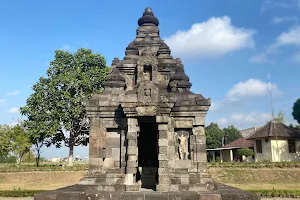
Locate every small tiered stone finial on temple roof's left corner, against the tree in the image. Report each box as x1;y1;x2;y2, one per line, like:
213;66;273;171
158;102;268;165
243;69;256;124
103;66;126;89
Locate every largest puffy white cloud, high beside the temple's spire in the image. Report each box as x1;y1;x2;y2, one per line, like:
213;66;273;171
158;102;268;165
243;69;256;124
165;16;255;57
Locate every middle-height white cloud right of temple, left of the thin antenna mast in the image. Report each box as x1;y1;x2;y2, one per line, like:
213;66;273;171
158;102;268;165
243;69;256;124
226;79;278;101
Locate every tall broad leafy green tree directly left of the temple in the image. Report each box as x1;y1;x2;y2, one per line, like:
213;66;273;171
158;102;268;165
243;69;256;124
21;49;109;166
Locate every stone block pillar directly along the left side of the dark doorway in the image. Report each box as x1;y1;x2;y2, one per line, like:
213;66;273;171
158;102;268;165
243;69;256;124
124;118;140;191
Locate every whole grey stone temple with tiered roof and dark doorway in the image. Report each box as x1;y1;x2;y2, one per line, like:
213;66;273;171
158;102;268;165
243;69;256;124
35;8;259;200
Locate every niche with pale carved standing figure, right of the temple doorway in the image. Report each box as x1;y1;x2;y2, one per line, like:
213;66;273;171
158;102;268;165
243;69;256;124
174;128;193;160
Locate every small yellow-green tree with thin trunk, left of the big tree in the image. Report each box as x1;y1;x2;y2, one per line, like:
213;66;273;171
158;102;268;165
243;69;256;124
10;124;32;166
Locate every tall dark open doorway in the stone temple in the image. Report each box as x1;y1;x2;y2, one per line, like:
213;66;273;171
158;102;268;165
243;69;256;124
137;117;158;190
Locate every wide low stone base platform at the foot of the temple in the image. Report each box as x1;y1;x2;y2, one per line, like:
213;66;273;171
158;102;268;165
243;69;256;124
34;184;260;200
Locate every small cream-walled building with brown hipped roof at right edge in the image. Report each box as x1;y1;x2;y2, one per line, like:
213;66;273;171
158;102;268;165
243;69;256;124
247;121;300;162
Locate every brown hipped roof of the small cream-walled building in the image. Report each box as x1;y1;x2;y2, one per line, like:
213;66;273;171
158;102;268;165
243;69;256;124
247;121;300;140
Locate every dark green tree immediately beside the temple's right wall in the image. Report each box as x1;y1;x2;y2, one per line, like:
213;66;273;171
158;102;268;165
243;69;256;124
205;123;224;149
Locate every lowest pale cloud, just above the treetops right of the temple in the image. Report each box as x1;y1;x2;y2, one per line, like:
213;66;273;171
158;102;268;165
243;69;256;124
217;112;272;127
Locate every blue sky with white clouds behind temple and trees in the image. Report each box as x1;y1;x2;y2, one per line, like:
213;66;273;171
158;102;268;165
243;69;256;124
0;0;300;157
